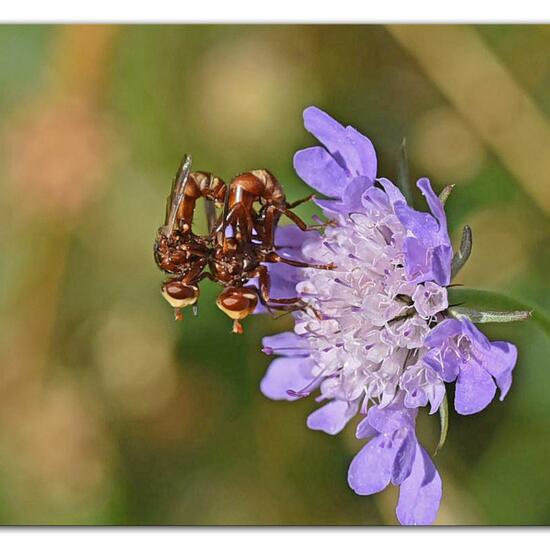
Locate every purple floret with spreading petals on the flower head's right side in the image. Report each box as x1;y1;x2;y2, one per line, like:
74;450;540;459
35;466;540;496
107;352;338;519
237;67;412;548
424;318;517;414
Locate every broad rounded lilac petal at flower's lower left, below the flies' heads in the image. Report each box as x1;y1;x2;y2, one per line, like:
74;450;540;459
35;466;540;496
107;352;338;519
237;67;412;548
260;357;314;401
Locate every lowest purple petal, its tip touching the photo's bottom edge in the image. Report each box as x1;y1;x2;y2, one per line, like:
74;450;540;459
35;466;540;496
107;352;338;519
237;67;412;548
396;443;441;525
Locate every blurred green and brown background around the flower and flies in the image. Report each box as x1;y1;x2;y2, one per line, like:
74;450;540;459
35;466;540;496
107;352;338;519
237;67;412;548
0;25;550;525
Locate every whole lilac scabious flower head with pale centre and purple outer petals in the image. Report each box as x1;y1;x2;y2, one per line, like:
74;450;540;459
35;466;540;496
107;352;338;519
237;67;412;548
261;107;517;524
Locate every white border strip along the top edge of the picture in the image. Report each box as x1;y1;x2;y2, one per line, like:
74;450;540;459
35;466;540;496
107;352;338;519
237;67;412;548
0;0;550;23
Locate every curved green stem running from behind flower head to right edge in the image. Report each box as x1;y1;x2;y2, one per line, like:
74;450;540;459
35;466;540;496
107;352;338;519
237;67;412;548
448;287;550;336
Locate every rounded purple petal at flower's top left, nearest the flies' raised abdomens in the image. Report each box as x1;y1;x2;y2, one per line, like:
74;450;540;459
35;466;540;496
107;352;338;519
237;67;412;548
294;147;349;198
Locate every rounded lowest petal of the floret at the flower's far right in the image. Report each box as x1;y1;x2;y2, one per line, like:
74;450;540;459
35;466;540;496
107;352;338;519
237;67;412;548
455;360;496;414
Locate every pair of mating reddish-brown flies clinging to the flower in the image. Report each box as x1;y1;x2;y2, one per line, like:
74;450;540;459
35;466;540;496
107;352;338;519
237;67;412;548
154;155;334;333
